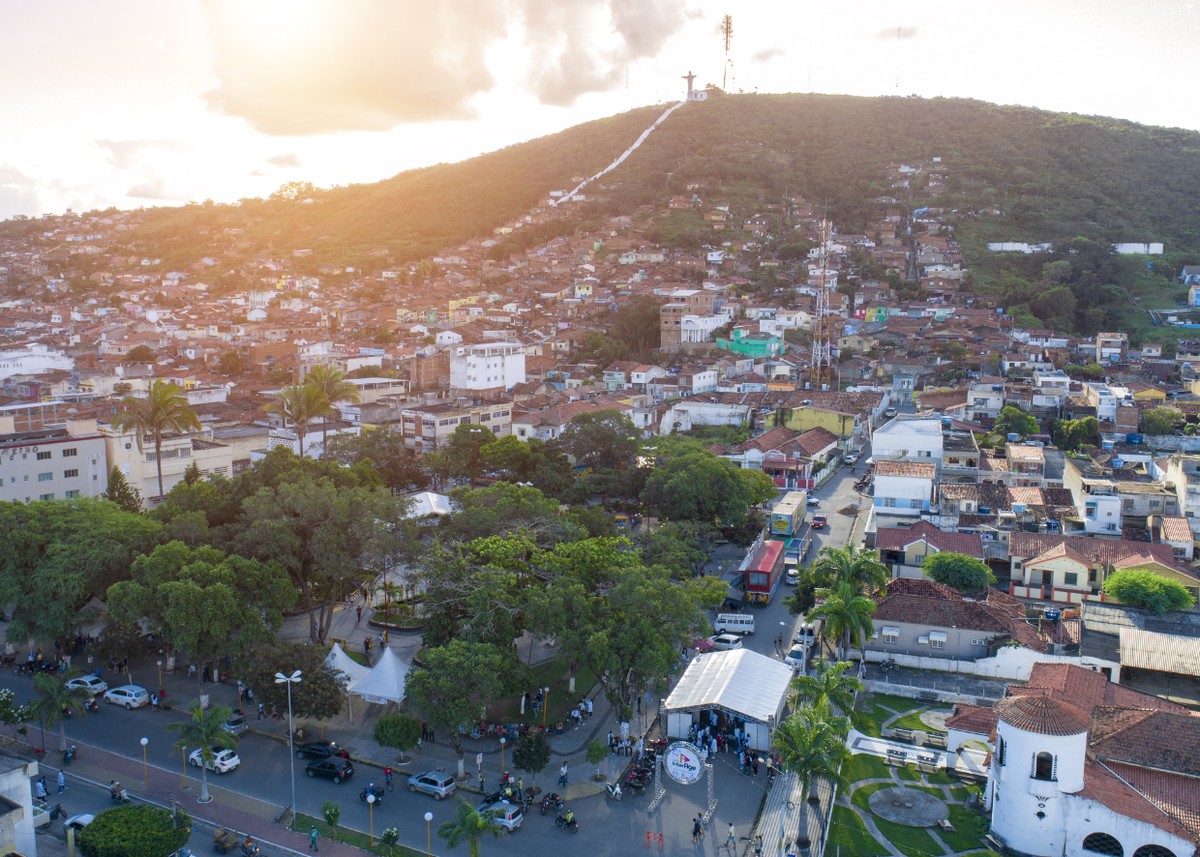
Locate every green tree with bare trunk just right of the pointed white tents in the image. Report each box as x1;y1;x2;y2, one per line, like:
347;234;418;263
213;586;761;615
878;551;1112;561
406;640;524;779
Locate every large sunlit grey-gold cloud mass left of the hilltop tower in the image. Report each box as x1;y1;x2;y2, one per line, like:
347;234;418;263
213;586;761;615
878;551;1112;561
202;0;686;136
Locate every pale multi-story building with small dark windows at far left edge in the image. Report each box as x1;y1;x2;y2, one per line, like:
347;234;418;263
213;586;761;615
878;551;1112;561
0;416;108;503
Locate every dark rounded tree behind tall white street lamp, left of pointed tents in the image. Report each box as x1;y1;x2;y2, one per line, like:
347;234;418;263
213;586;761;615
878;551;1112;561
239;643;347;720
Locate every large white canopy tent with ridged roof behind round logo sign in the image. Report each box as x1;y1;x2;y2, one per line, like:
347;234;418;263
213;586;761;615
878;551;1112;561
664;648;792;749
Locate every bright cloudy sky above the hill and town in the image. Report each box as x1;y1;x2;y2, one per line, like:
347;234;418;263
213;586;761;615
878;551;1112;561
0;0;1200;218
